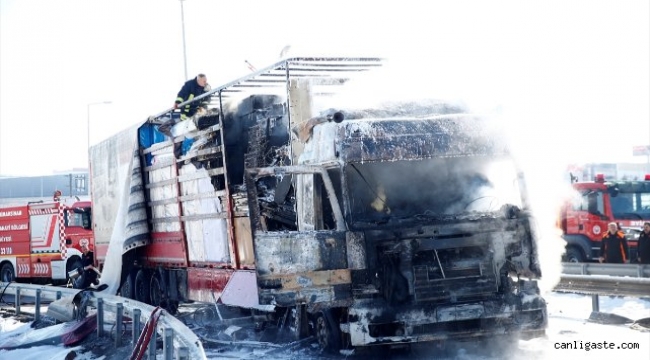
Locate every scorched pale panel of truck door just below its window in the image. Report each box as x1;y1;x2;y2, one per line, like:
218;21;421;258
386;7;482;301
254;231;348;276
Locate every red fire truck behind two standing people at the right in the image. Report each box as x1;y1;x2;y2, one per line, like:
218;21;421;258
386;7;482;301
558;174;650;262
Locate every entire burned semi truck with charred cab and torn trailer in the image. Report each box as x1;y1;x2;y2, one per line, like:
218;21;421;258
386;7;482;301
91;58;547;351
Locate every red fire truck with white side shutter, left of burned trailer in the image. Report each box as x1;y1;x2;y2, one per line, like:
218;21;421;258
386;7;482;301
0;197;94;284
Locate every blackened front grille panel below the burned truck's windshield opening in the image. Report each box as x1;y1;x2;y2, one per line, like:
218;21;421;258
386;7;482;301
353;216;531;306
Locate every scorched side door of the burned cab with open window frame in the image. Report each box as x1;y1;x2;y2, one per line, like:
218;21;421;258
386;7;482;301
247;166;351;306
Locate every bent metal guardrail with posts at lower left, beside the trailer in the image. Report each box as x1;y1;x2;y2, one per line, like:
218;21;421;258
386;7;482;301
0;282;206;360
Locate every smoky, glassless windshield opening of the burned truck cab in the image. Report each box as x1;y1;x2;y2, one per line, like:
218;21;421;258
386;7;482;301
345;155;524;223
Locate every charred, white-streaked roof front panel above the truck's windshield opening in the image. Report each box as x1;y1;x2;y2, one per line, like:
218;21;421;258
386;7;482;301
337;116;507;162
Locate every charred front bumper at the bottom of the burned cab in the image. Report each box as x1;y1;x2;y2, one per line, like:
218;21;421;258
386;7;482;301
347;291;547;346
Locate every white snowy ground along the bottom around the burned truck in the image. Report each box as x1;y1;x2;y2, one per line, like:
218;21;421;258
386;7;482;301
0;292;650;360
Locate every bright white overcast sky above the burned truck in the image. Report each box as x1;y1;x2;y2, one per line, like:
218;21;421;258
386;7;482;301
0;0;650;175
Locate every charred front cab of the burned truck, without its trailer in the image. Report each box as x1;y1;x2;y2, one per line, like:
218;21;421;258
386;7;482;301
251;108;547;347
